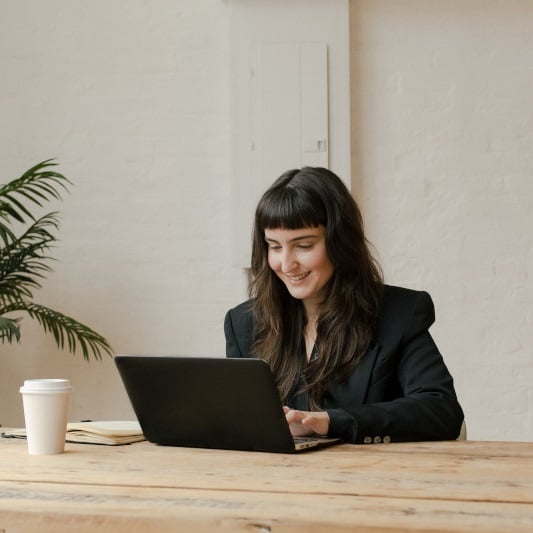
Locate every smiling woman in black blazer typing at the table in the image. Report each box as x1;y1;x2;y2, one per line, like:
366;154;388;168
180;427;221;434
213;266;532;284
224;167;463;443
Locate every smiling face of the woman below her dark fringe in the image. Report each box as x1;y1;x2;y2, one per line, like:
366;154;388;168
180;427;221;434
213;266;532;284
265;226;335;305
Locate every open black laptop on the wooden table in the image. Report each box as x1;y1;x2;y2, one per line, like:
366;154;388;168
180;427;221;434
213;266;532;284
114;355;341;453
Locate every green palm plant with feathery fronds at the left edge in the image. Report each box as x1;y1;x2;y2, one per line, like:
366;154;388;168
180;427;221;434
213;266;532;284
0;159;112;360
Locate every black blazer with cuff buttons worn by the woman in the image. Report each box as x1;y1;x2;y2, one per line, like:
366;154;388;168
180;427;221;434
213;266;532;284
224;285;464;443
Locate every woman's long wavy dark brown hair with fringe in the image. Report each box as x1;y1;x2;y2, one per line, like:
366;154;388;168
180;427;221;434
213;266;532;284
249;167;383;409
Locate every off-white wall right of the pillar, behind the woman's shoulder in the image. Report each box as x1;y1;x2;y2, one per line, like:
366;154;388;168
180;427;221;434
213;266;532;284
350;0;533;440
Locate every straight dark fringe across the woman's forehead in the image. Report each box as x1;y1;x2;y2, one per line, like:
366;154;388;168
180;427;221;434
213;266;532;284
256;187;327;230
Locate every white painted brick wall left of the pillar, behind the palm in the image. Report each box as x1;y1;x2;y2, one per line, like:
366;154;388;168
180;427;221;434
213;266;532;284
0;0;246;426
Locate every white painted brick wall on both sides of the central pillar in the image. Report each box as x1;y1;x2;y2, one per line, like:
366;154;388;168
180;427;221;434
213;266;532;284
0;0;533;440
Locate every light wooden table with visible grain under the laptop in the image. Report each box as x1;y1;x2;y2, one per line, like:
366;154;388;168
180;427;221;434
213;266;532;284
0;439;533;533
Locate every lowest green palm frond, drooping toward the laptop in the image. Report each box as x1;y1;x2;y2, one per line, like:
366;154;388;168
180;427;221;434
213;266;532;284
2;300;113;361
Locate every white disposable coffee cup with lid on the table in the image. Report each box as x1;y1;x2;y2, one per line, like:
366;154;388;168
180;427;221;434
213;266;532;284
20;379;72;455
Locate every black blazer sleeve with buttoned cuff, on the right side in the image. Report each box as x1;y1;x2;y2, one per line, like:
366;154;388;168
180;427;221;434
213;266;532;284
327;291;464;443
